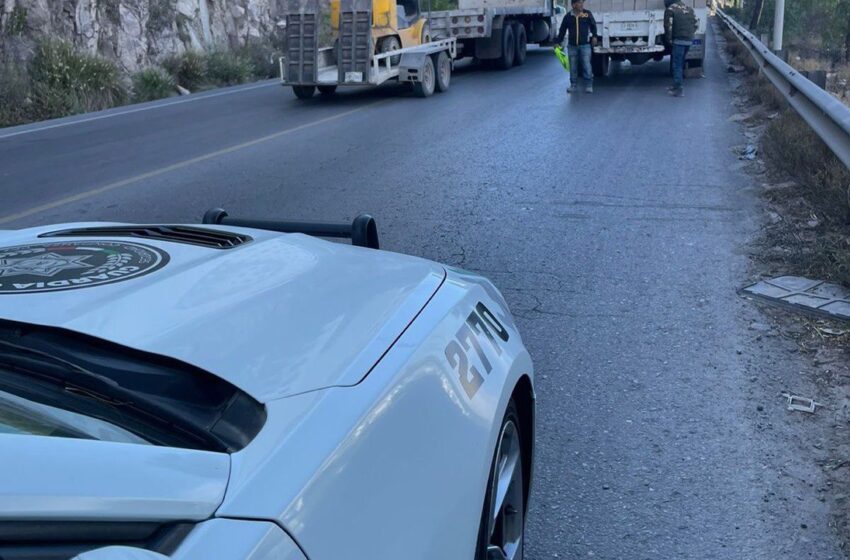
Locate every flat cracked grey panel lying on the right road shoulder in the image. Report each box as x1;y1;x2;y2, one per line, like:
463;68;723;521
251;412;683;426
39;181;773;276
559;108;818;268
741;276;850;321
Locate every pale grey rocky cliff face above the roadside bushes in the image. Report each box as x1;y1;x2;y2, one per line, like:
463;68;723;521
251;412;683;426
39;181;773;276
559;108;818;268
0;0;282;73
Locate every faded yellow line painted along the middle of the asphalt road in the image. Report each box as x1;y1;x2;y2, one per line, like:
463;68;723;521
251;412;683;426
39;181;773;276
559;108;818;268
0;99;387;224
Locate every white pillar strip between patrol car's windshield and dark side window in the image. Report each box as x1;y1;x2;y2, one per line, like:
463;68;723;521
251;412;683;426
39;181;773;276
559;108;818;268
0;435;230;521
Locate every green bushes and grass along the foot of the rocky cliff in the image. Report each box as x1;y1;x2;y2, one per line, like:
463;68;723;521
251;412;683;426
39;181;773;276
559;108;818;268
0;37;279;127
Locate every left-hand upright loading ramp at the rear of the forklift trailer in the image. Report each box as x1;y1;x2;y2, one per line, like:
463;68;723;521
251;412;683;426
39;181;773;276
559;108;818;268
284;0;319;84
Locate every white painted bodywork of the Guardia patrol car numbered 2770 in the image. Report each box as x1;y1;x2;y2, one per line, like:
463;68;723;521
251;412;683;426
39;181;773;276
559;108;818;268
0;224;534;560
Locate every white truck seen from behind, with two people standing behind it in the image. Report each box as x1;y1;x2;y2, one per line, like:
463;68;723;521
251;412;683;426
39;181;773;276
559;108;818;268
584;0;708;76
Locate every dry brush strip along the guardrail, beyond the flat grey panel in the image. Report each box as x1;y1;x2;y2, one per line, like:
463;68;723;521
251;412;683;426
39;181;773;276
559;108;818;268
725;22;850;286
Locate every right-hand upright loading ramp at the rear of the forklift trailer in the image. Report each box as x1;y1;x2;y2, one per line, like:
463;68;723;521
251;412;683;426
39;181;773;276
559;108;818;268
338;0;374;84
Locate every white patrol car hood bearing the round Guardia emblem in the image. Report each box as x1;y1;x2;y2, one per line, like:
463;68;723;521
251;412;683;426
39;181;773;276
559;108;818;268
0;223;445;402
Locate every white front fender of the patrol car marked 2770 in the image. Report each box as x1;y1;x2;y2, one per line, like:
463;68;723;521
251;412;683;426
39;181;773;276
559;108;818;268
219;274;532;560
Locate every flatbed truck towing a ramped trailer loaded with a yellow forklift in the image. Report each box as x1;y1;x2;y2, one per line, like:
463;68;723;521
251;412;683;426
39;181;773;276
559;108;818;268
280;0;563;99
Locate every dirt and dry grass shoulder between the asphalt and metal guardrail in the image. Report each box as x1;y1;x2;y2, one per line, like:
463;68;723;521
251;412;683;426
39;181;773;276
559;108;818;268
714;17;850;558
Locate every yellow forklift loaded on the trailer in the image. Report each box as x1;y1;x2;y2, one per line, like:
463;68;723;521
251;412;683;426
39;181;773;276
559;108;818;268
331;0;431;54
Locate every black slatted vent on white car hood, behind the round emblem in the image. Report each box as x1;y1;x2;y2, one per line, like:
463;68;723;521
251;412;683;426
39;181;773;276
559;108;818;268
39;225;251;249
